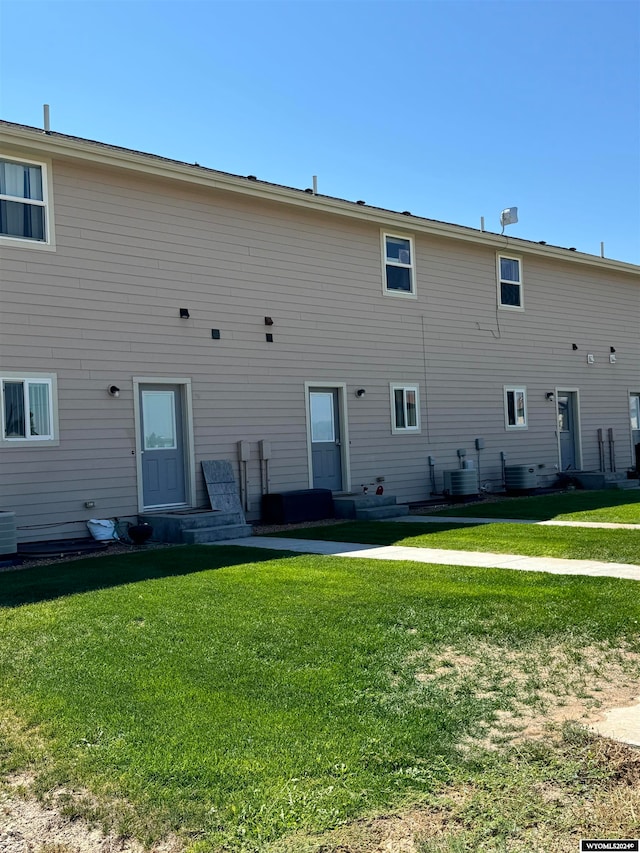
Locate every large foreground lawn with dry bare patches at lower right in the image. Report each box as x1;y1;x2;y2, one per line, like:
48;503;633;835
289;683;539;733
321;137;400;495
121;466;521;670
0;544;640;853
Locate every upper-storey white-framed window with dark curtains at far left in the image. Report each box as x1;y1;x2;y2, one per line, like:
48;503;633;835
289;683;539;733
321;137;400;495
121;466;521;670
0;154;53;247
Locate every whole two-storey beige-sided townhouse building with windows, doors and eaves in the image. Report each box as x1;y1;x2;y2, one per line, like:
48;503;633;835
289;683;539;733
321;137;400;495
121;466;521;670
0;122;640;542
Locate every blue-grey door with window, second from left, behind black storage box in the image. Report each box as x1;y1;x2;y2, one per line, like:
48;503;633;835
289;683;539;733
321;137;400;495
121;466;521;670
308;388;343;492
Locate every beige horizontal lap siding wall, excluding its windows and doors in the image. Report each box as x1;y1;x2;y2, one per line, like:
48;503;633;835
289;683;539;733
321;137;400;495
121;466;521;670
0;137;640;541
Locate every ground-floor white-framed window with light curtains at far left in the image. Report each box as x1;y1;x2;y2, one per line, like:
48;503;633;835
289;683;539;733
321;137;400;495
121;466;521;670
0;373;59;445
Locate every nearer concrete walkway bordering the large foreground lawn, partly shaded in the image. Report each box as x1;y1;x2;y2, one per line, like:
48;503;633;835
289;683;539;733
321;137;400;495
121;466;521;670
218;536;640;580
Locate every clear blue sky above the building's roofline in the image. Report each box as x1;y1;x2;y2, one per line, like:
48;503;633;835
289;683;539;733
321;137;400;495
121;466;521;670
0;0;640;263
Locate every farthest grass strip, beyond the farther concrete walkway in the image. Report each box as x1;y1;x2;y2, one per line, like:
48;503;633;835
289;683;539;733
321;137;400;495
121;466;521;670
434;489;640;524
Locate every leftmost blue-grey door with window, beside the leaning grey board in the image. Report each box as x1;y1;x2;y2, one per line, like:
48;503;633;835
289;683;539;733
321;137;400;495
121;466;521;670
140;385;187;509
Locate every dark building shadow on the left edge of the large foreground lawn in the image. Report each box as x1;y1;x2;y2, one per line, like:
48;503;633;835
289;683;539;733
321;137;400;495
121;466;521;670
0;545;298;607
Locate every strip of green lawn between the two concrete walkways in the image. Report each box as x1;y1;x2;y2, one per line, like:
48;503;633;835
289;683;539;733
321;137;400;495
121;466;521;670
273;518;640;565
